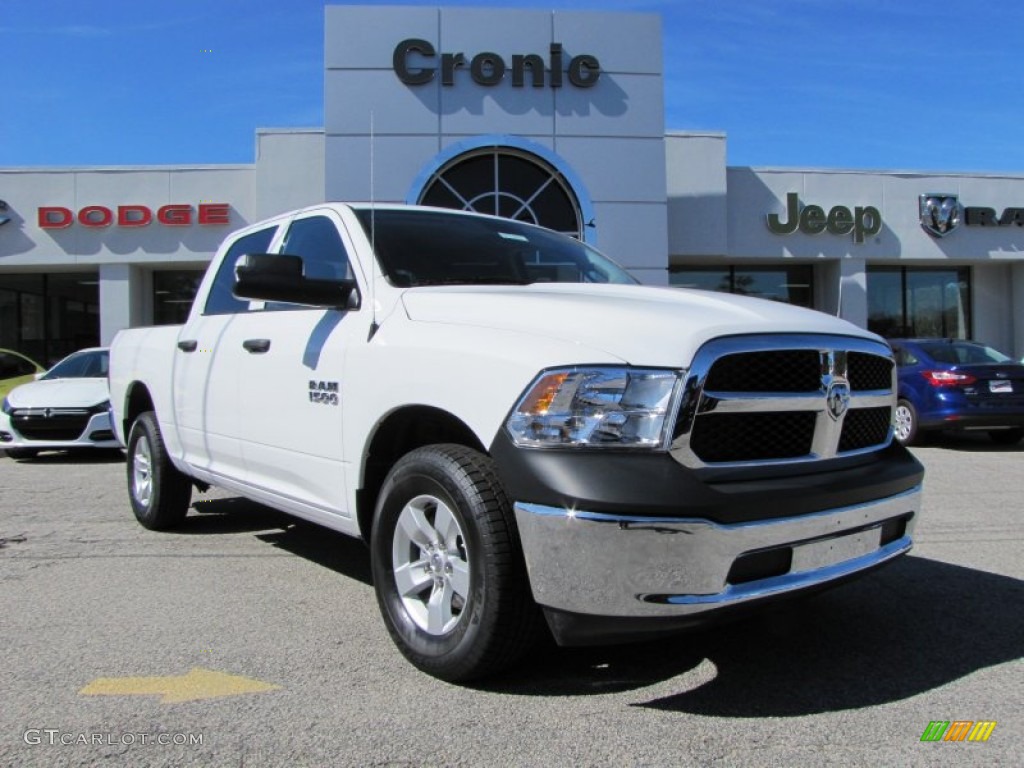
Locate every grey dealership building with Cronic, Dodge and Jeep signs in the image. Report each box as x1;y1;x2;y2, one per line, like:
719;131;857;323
0;5;1024;362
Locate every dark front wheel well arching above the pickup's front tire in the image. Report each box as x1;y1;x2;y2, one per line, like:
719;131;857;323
356;406;486;543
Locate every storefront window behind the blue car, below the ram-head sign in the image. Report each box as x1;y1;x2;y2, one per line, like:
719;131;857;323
867;266;971;339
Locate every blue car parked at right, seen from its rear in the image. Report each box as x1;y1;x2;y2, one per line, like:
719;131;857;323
889;339;1024;445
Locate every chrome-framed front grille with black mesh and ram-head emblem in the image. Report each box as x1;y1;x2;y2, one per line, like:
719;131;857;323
670;334;896;469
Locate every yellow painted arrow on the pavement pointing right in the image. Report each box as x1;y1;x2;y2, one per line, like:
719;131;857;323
79;667;281;703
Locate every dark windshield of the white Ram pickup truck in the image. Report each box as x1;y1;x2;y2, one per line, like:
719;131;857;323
355;209;638;288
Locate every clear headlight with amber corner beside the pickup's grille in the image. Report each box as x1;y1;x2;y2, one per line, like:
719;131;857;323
506;367;682;451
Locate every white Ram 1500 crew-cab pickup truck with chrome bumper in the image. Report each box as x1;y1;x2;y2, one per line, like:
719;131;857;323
111;204;923;681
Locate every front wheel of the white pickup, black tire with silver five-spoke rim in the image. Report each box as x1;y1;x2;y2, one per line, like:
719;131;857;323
371;444;542;683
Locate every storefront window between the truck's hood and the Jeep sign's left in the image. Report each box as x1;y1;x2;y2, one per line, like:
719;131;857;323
669;264;814;307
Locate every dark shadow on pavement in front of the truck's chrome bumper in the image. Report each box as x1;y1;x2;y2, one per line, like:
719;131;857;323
488;557;1024;718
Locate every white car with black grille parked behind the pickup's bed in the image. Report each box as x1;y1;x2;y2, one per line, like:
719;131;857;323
0;347;120;459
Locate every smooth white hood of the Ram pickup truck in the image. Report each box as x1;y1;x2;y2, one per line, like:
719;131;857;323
402;283;878;368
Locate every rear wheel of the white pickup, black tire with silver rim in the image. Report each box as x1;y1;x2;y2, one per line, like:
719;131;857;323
127;411;191;530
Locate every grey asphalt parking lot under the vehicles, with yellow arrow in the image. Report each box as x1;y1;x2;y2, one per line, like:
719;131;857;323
0;437;1024;767
